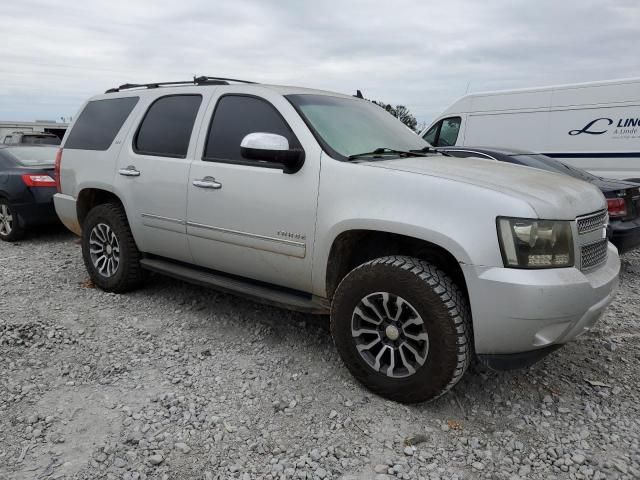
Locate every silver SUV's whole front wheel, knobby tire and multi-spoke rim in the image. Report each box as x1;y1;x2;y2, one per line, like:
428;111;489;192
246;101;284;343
331;256;471;403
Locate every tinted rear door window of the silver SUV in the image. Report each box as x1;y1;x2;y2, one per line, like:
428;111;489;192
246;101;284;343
133;95;202;158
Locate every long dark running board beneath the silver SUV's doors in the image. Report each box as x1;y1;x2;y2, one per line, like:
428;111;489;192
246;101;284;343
140;258;329;315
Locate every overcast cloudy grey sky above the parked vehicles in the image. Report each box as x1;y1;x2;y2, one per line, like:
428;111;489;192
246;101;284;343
0;0;640;123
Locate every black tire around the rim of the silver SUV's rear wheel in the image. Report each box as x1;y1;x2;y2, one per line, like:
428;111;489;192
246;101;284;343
82;203;145;293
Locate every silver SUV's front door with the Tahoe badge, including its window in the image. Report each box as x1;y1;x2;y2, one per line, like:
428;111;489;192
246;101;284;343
187;86;321;291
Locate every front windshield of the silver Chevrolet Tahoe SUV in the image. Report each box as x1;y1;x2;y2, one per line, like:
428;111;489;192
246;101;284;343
287;94;429;160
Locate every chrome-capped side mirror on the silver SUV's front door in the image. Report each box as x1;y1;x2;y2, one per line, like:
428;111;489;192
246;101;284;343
240;132;304;173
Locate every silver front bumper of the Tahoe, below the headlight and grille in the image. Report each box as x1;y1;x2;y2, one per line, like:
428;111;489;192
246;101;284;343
462;244;620;355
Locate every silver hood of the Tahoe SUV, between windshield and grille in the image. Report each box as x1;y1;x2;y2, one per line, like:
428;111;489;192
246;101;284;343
362;155;606;220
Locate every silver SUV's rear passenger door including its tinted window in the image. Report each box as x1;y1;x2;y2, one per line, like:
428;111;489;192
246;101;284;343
114;87;210;262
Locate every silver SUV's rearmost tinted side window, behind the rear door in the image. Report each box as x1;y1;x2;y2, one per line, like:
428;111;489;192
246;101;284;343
64;97;138;150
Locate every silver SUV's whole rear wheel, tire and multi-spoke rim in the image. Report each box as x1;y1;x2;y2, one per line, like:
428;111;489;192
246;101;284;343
82;203;144;293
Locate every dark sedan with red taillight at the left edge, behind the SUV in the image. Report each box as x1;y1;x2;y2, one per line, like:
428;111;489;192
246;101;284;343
0;145;59;242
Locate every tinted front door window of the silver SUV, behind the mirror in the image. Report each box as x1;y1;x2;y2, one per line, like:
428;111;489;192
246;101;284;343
202;95;301;164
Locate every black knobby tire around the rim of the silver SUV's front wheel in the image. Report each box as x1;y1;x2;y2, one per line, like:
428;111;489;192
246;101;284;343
331;256;472;403
